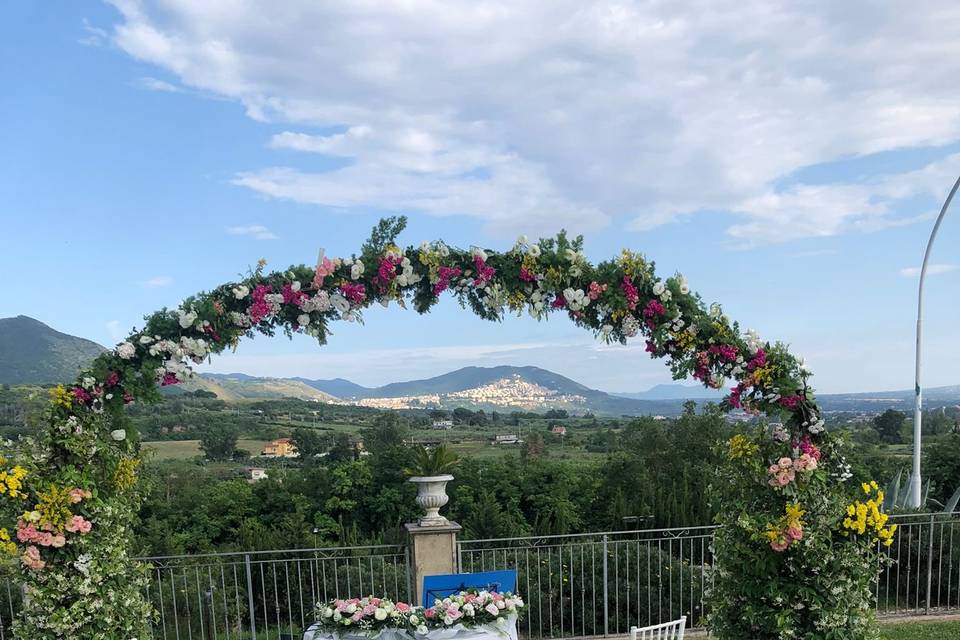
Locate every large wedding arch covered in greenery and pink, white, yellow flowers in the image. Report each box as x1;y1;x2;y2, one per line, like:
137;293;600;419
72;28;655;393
7;218;892;640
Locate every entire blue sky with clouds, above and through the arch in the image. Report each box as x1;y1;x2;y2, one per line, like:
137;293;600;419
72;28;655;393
0;0;960;392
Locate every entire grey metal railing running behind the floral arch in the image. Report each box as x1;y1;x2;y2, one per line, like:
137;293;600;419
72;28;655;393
0;512;960;640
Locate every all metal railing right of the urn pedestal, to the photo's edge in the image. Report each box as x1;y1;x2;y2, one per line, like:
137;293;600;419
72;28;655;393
458;512;960;638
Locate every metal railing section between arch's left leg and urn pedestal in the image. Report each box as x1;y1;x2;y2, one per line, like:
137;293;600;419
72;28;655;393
143;545;412;640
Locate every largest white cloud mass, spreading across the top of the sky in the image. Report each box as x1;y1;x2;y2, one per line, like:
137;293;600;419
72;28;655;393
107;0;960;244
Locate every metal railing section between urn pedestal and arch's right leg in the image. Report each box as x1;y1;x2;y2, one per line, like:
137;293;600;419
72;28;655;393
458;526;716;638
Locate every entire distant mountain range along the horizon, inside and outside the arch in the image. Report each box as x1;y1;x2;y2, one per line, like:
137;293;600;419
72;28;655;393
0;316;960;415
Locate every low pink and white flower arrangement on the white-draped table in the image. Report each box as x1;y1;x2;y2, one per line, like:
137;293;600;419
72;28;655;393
316;590;526;637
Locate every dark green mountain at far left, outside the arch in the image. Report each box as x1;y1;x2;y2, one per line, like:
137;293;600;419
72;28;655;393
0;316;106;384
